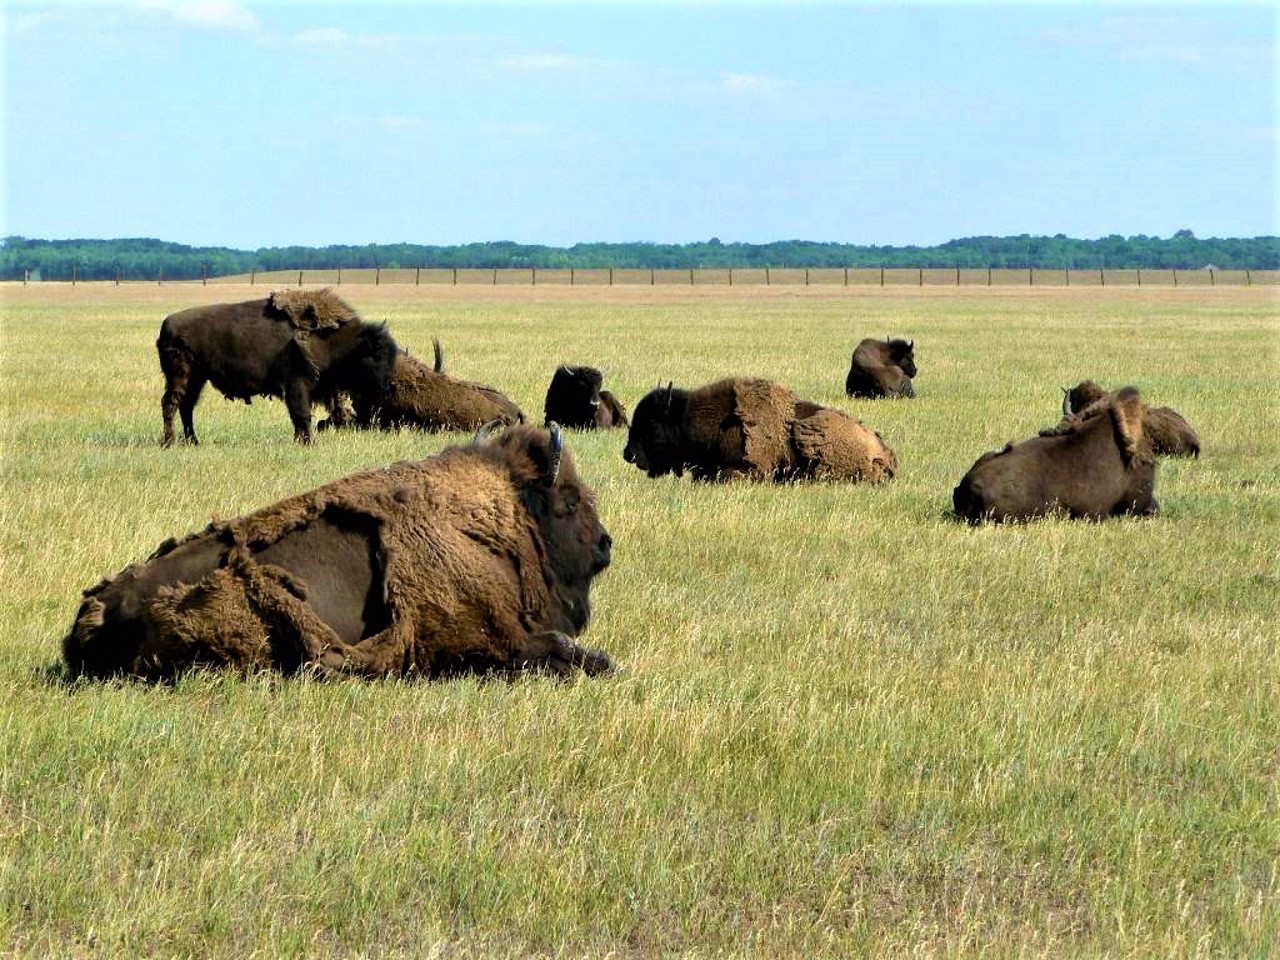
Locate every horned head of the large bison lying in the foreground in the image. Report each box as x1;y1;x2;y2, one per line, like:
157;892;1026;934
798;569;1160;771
476;424;613;634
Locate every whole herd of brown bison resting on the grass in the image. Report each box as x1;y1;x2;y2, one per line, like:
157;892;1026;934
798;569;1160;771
63;289;1201;680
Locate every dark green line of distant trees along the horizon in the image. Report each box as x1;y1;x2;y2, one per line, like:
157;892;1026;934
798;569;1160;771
0;230;1280;280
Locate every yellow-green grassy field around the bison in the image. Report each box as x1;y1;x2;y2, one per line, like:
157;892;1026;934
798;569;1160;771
0;284;1280;957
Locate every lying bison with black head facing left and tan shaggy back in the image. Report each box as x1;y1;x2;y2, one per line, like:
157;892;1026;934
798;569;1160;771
622;379;897;481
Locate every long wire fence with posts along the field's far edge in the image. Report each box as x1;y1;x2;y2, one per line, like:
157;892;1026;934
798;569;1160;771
15;266;1280;289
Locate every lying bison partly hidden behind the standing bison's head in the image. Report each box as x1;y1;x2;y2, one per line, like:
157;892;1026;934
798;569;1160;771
324;340;525;430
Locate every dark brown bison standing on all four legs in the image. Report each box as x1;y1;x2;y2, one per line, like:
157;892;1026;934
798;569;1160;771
156;289;396;447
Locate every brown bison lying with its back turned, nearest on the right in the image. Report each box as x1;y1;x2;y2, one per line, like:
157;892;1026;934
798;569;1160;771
951;387;1158;524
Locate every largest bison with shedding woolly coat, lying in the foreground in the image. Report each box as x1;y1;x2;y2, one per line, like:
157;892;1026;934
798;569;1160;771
63;426;612;680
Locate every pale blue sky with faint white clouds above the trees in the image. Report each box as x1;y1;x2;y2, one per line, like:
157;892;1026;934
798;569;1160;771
0;0;1280;250
